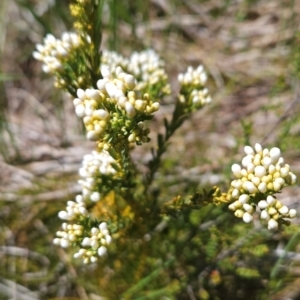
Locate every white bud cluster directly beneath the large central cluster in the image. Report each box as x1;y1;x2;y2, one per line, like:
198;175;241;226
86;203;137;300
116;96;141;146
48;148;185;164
78;150;117;202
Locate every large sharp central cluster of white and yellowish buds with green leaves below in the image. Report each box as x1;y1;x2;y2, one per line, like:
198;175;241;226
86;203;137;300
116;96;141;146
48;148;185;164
73;67;159;148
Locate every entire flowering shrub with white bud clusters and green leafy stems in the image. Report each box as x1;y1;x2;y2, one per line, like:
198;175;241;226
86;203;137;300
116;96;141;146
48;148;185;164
33;0;296;299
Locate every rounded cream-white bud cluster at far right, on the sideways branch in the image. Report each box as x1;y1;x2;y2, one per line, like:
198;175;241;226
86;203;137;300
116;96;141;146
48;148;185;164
229;144;296;229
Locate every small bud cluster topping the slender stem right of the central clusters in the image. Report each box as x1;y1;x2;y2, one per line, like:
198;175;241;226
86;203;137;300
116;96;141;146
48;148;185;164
178;65;211;109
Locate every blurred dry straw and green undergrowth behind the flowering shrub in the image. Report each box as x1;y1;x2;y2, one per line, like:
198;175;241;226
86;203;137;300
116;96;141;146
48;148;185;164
0;0;300;300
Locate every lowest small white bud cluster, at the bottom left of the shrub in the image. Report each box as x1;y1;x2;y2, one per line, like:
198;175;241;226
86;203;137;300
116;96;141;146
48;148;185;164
74;222;112;264
